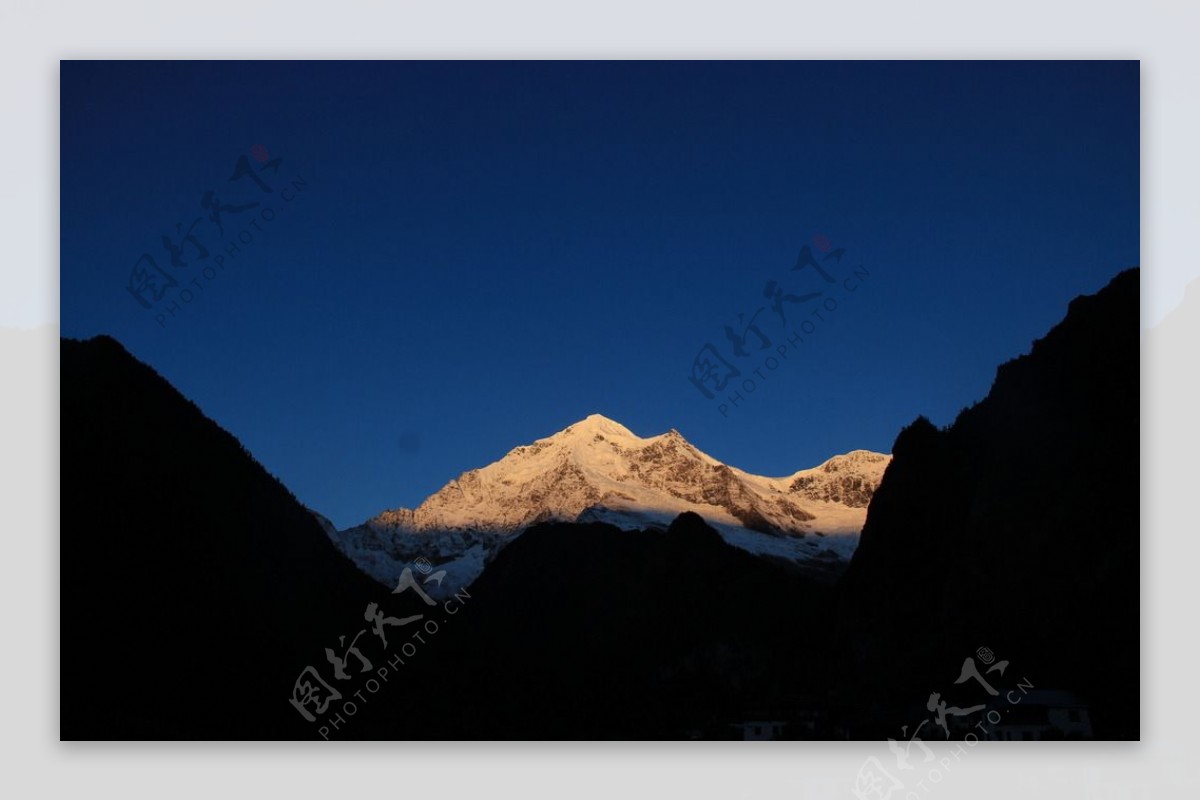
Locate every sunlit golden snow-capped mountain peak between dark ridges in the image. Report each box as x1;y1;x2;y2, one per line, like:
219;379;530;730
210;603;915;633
331;414;890;586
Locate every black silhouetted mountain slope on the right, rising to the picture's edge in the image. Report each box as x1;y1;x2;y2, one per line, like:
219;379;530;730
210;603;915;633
839;269;1140;739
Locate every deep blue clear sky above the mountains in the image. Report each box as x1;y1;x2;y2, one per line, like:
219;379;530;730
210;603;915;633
61;61;1139;526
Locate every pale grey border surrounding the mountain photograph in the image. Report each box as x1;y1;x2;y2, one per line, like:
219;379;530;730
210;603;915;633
0;0;1200;799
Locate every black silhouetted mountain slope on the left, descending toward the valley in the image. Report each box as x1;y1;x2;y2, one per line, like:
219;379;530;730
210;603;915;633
60;337;385;740
